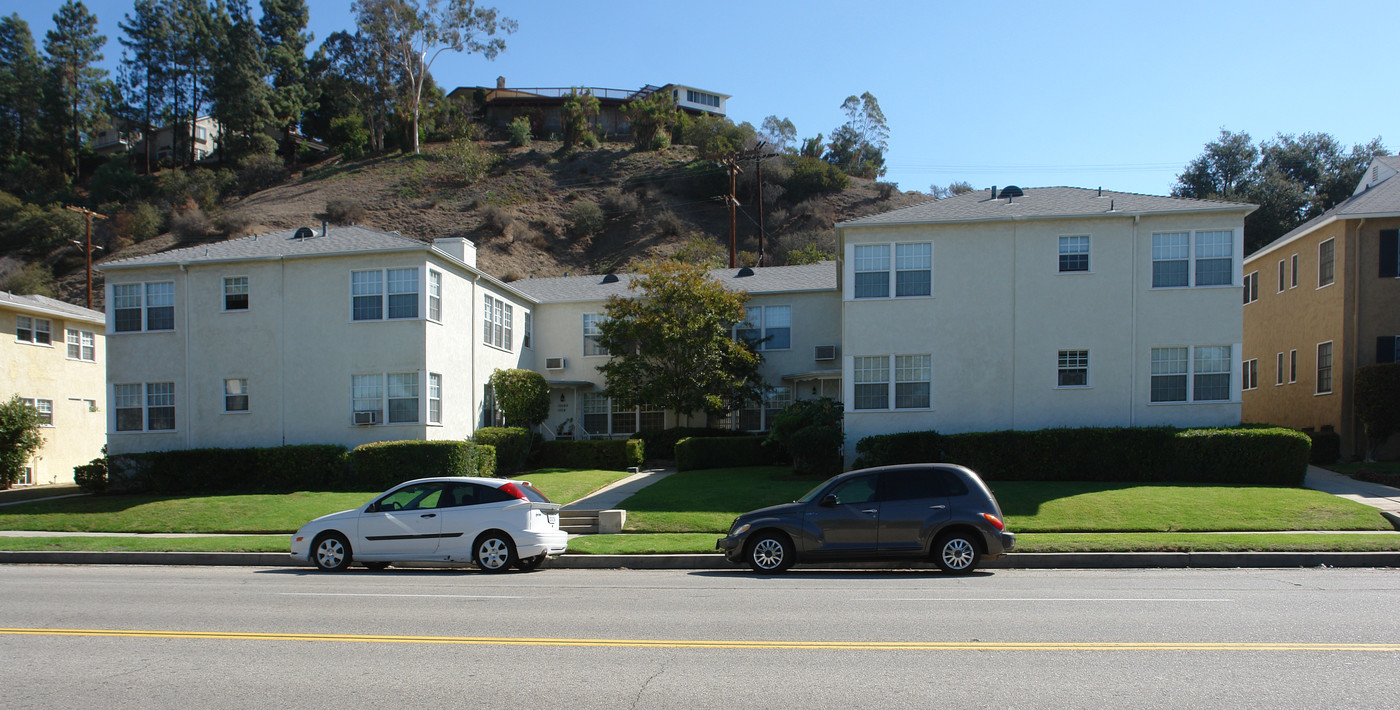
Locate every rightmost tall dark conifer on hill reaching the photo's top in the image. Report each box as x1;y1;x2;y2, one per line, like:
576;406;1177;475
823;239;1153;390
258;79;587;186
258;0;315;157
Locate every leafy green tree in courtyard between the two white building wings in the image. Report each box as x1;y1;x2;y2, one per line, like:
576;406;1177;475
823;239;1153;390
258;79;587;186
598;260;763;416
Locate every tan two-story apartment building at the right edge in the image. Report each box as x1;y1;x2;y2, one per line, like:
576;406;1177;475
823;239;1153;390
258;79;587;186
1243;155;1400;458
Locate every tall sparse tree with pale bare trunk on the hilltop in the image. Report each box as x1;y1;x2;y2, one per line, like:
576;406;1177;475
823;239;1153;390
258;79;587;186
353;0;517;153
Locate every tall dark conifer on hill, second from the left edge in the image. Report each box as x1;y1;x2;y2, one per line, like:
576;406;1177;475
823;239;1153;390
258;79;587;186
43;0;106;179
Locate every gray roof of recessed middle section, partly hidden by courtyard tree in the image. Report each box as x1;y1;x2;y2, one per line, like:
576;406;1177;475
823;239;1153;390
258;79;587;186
510;262;836;302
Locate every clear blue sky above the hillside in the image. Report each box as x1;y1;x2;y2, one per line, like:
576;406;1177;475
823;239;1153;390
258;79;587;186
0;0;1400;195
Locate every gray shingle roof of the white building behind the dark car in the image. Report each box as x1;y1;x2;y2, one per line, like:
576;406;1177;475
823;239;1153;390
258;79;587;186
837;188;1256;228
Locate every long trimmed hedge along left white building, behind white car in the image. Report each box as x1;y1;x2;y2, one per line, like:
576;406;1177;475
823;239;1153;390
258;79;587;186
103;441;496;493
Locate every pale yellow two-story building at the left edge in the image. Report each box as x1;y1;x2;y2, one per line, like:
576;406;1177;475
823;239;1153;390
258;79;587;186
0;291;106;485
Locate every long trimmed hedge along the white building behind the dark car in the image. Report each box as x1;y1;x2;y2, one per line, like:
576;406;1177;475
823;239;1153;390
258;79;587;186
855;427;1310;486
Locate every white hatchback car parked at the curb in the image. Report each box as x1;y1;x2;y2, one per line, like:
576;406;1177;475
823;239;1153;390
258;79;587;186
291;478;568;571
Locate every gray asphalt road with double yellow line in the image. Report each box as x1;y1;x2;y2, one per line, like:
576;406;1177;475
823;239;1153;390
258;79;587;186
0;566;1400;710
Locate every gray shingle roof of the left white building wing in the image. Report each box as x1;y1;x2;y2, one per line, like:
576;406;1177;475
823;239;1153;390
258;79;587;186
98;227;428;270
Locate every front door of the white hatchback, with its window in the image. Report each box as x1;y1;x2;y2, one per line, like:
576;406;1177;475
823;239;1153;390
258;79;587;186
353;483;442;557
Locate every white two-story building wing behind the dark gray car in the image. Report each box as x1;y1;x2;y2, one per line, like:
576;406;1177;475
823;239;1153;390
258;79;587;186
837;188;1254;464
